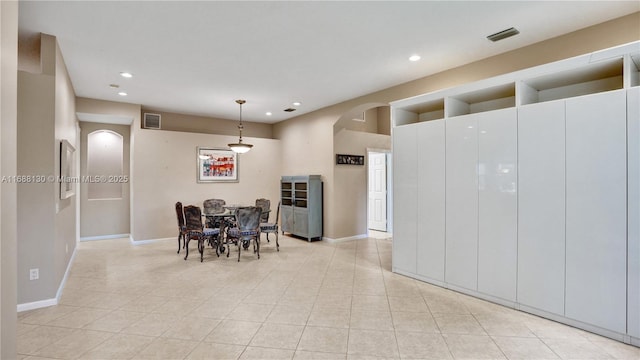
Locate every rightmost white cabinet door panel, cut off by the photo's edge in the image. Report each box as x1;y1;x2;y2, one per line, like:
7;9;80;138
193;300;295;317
627;87;640;338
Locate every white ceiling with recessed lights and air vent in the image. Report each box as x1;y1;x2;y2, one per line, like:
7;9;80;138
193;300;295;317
19;1;640;123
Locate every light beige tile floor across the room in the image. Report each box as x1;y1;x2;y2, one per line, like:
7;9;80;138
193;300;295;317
17;233;640;360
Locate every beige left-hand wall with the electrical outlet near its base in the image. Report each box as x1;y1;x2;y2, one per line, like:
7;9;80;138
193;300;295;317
17;35;77;304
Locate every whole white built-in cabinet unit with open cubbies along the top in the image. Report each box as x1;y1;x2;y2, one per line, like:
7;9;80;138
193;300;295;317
392;42;640;346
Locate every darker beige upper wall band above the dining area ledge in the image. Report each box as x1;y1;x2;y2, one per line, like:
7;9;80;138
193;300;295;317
142;108;273;139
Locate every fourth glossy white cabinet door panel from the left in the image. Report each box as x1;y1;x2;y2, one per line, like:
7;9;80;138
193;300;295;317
476;108;518;301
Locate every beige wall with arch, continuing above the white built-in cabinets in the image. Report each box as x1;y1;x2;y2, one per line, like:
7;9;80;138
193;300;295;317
273;12;640;239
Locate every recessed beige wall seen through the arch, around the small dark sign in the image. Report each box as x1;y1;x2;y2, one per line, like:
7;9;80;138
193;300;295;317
332;103;391;239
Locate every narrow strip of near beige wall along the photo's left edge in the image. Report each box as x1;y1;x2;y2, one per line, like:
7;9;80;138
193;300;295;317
0;1;18;359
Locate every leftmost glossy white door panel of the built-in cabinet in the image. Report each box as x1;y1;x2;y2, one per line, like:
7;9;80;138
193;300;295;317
393;125;418;274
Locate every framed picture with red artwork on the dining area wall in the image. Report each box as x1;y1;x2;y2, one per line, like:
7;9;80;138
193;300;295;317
196;146;239;183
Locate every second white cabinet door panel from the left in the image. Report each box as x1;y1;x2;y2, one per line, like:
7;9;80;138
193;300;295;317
417;120;445;281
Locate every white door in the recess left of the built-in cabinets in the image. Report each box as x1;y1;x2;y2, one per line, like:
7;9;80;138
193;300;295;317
369;152;387;231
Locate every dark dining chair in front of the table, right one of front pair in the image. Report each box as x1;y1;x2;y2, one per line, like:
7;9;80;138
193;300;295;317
227;206;262;261
